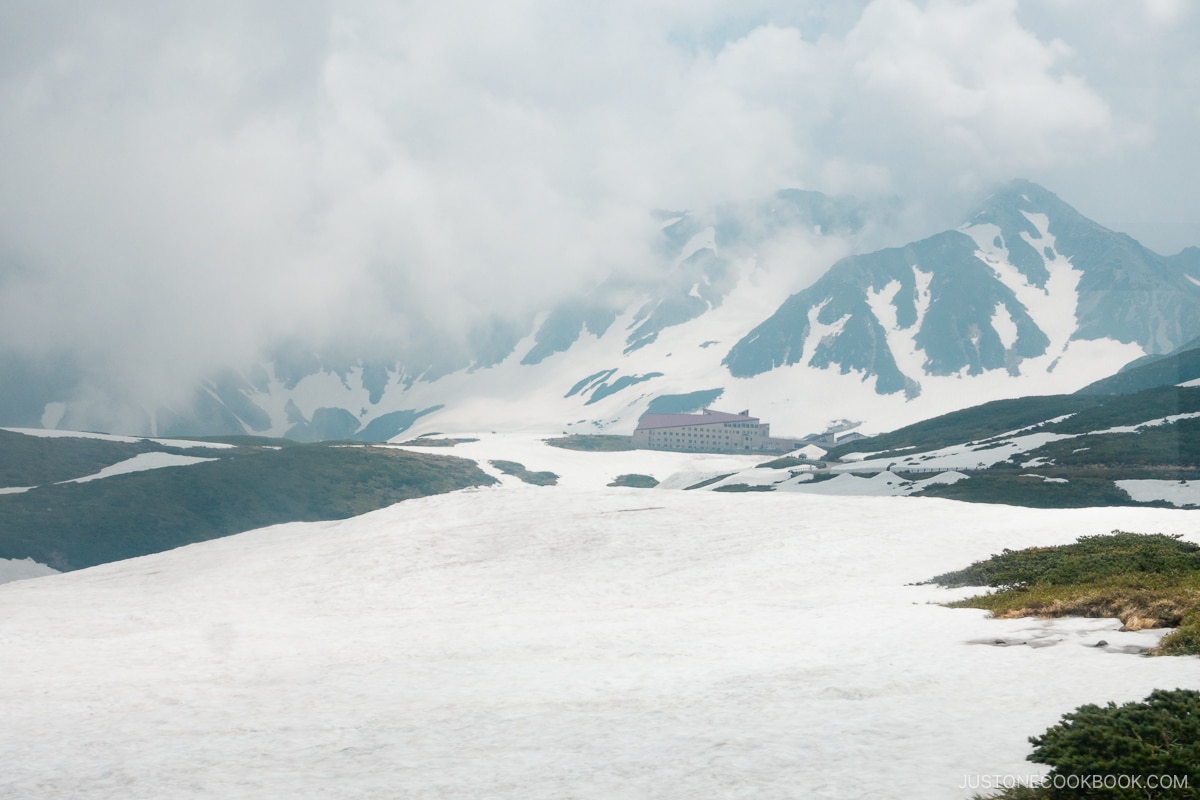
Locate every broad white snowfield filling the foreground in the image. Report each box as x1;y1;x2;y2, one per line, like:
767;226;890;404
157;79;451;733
0;439;1200;800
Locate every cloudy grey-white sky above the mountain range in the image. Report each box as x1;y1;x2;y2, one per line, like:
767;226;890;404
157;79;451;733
0;0;1200;400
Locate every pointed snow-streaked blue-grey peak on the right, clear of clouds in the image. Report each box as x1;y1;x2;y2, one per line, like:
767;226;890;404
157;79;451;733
725;181;1200;397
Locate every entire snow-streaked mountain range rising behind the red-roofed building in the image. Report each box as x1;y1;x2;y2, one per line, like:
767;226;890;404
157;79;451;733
9;181;1200;440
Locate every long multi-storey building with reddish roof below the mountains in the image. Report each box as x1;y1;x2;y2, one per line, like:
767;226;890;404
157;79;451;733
634;408;799;453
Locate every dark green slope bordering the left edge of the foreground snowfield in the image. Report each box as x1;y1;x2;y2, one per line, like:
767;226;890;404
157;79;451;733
0;444;494;570
